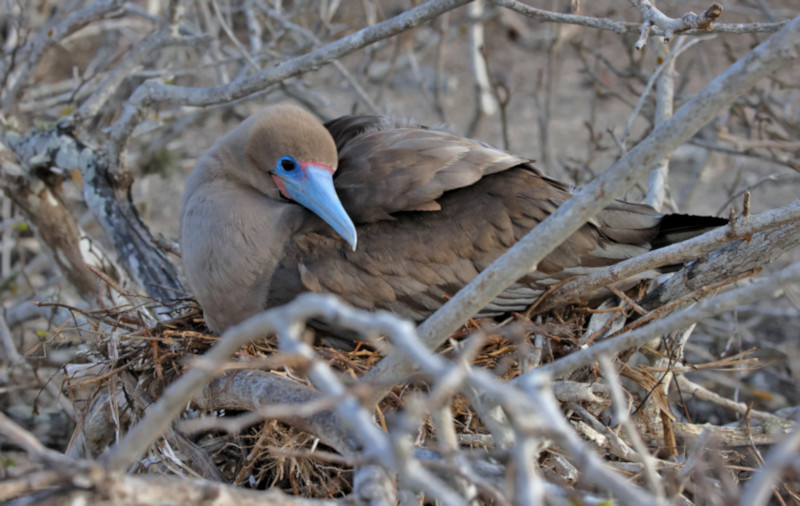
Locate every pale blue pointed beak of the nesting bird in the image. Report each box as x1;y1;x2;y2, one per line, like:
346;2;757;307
273;162;358;251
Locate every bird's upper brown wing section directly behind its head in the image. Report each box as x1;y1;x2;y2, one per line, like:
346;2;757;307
325;116;535;223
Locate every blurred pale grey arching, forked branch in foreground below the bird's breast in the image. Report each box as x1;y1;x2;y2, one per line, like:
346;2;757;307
94;294;652;504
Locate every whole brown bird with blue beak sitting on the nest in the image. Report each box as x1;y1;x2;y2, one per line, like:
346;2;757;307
181;105;724;332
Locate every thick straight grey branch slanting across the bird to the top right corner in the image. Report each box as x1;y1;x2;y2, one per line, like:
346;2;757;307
365;11;800;403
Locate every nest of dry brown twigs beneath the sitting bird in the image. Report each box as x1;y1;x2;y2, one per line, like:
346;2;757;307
53;284;792;499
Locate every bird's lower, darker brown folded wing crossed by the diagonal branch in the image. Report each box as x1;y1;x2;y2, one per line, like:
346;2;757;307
267;165;661;321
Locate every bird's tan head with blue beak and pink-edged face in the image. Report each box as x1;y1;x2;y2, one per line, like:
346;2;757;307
237;104;357;250
